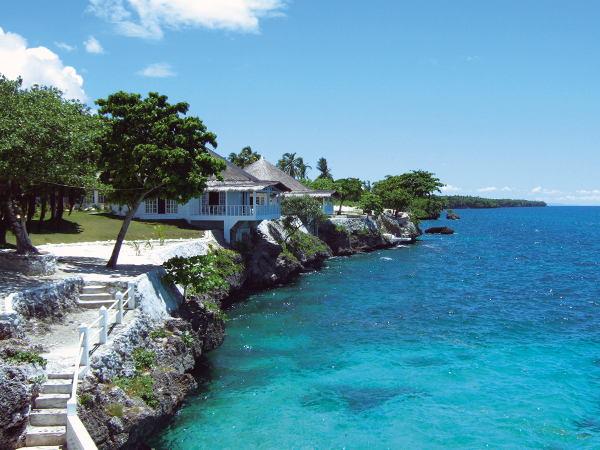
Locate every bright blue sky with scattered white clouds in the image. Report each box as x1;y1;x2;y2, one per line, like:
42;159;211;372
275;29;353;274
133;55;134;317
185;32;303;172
0;0;600;206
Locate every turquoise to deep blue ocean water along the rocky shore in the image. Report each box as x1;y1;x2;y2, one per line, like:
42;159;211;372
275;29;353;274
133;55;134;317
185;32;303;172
149;207;600;450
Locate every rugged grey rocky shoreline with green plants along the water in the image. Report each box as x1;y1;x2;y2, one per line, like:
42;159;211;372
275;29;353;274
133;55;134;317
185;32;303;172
0;216;421;450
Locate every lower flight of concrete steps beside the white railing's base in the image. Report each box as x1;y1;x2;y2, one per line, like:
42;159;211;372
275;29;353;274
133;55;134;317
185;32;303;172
24;373;73;450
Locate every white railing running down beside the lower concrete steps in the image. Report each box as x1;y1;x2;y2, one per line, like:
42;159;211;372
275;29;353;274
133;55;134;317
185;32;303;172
67;282;135;450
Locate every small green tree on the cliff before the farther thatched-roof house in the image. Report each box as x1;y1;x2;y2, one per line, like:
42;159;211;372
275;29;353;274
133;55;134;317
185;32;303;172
281;195;327;242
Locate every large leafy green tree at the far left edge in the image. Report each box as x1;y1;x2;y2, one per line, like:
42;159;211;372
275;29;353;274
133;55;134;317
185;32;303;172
0;76;102;254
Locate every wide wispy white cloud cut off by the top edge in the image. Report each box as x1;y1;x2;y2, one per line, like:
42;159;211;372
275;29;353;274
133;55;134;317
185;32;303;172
88;0;286;39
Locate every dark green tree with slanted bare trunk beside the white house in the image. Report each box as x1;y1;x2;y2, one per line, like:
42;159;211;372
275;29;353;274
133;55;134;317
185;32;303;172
96;91;226;268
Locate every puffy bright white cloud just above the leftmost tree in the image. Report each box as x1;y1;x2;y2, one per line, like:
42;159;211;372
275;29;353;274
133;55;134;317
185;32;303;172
0;28;87;100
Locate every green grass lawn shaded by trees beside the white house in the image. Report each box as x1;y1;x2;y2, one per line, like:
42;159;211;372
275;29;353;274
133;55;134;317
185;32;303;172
6;211;204;248
